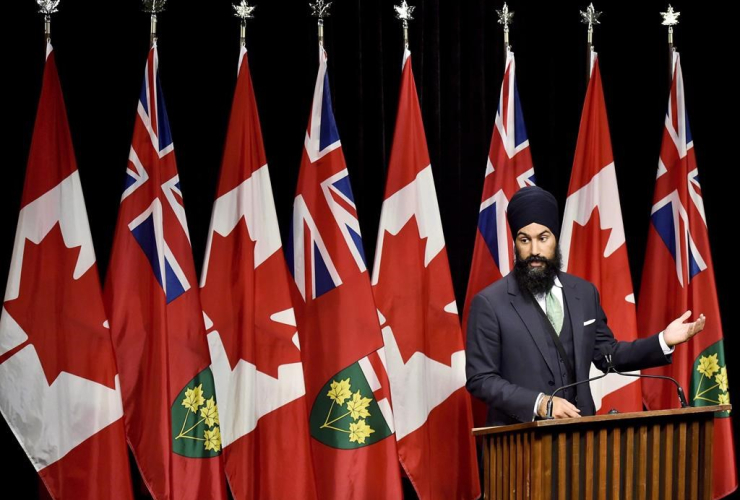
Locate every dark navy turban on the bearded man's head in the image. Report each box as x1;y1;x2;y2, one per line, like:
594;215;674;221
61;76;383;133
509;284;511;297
506;186;560;240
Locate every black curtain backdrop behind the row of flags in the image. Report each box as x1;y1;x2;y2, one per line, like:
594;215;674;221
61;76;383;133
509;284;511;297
0;0;740;498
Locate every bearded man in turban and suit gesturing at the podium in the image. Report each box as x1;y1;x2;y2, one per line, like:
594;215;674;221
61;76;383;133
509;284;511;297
466;186;705;425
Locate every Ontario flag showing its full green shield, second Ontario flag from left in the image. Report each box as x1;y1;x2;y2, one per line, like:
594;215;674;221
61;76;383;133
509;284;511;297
286;45;402;499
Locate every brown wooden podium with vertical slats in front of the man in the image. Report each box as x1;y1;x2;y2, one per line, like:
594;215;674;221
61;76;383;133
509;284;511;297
473;405;731;500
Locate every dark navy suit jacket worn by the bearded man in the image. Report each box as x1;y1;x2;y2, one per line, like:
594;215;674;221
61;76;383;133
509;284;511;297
466;272;671;425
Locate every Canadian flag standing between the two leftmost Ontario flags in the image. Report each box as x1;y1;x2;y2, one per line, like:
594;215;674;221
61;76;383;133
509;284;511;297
201;47;316;499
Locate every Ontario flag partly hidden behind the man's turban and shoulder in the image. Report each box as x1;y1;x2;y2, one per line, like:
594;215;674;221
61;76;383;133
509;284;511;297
462;51;535;427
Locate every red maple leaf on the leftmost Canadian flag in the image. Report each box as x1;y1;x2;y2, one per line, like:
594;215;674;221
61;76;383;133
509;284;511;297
5;224;116;389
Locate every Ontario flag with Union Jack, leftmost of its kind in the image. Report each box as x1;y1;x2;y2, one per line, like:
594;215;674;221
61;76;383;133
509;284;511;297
105;45;226;500
